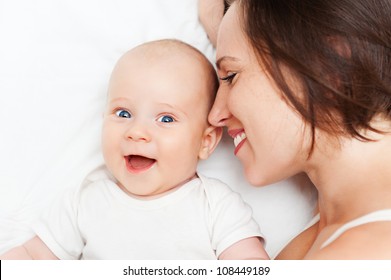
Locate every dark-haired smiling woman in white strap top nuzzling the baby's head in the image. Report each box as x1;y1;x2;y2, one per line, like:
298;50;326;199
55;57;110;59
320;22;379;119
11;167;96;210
209;0;391;259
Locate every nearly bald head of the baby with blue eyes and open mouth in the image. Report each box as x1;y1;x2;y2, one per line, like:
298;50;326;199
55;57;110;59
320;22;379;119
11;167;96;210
102;40;222;197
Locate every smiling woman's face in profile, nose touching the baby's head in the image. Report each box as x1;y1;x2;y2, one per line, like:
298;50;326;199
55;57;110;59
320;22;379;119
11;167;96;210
209;3;310;185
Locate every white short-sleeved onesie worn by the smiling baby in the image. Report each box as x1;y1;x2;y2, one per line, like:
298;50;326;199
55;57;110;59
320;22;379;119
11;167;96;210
33;166;262;260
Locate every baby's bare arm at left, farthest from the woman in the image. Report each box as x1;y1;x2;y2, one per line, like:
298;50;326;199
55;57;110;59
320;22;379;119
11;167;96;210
0;236;58;260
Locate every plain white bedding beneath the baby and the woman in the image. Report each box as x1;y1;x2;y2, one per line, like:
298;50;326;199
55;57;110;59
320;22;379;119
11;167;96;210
0;0;315;256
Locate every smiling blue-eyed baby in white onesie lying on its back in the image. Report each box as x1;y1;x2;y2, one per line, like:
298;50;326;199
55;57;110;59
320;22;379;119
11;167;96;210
1;40;268;259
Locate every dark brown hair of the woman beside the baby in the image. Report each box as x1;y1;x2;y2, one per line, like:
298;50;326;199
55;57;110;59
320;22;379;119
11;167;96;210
236;0;391;151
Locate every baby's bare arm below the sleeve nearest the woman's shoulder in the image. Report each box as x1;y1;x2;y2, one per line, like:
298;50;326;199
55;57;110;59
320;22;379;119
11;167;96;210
219;237;270;260
